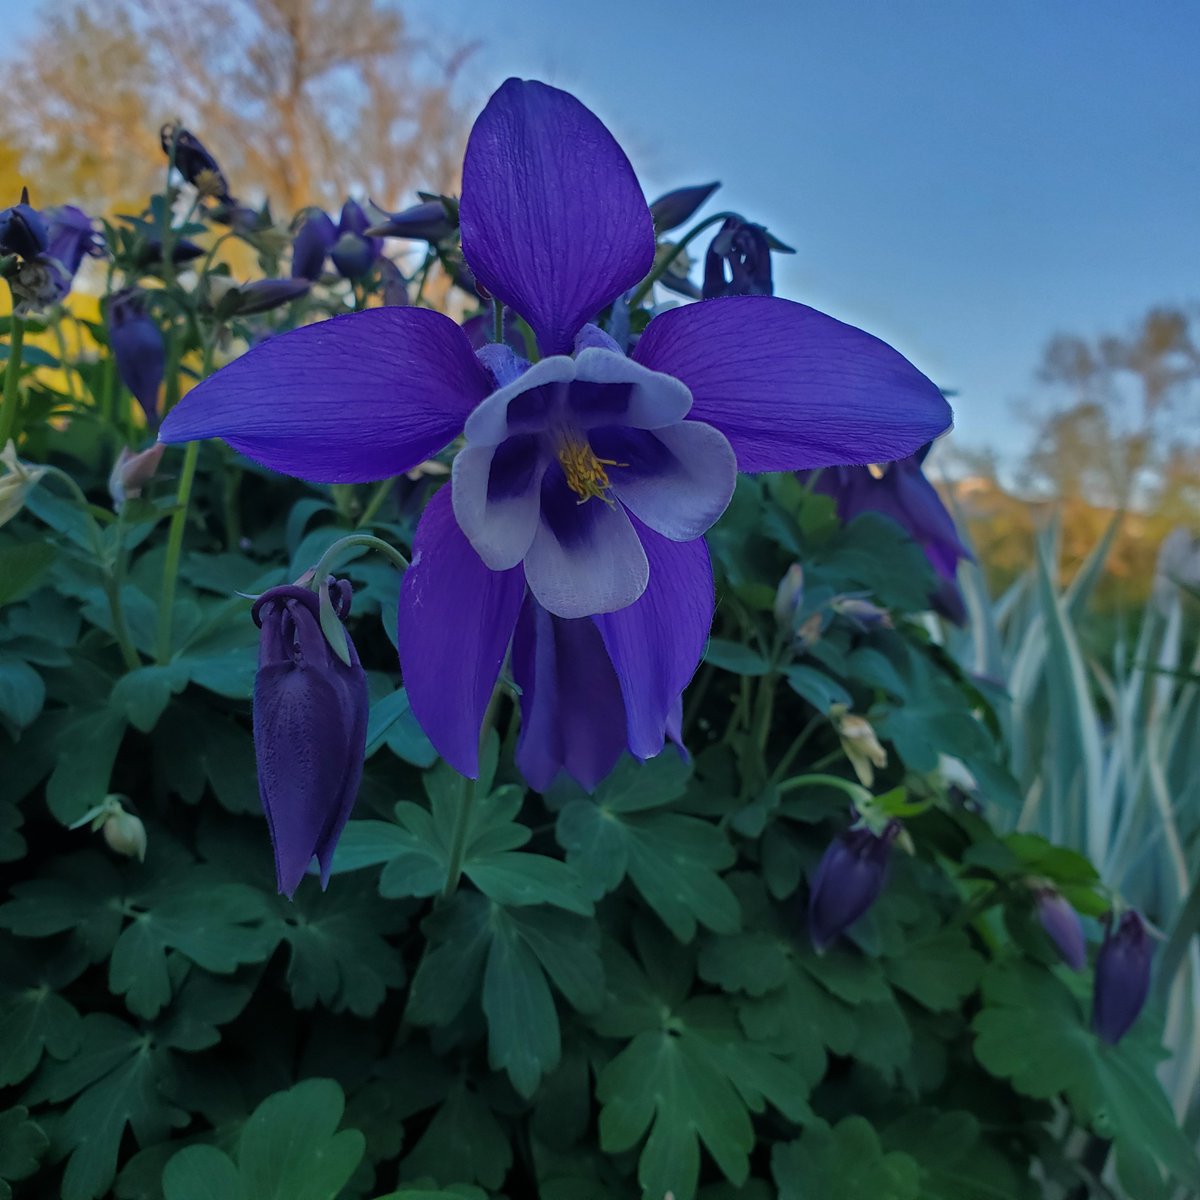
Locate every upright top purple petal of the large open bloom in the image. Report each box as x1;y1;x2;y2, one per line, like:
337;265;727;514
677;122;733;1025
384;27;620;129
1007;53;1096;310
458;79;654;355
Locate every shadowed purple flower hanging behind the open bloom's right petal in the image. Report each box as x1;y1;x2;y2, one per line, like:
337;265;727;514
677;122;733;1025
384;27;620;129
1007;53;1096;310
812;443;973;625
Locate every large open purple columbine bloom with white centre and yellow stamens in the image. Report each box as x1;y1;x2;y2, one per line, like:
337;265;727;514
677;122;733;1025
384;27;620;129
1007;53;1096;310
161;79;950;782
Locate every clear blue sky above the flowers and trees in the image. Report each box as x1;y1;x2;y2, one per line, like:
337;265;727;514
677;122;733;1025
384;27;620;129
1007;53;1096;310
8;0;1200;465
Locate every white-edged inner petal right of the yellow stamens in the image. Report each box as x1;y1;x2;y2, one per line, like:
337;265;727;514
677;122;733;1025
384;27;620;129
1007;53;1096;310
589;421;738;541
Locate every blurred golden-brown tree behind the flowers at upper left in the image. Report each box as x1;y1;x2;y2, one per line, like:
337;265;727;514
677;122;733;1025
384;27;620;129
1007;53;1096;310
0;0;472;212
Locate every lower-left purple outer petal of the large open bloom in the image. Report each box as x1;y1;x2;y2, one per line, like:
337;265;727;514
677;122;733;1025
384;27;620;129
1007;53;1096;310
396;487;524;779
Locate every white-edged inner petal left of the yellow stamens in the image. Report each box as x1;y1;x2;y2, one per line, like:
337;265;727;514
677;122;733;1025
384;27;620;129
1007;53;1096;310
451;433;546;571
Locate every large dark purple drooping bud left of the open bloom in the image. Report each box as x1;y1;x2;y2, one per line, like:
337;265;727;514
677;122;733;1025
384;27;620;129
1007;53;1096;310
252;578;370;896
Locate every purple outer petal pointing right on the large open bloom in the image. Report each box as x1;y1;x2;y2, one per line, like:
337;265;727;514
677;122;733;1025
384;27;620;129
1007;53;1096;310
634;296;950;470
